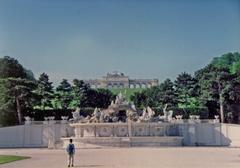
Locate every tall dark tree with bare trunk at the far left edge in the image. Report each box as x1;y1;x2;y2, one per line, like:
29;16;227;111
0;56;36;126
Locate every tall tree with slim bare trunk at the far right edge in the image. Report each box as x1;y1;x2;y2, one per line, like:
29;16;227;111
195;53;240;121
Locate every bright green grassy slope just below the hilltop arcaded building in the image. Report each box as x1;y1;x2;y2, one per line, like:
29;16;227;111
109;88;143;101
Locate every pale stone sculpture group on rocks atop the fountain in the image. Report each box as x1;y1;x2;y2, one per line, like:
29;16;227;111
72;92;173;123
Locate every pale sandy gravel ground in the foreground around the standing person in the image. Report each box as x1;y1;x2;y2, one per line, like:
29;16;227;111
0;147;240;168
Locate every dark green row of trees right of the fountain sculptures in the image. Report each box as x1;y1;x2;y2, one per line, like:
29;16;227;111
131;52;240;122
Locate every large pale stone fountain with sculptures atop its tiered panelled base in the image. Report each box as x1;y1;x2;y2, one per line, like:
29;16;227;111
62;92;183;147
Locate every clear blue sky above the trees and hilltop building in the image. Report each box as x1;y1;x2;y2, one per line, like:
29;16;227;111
0;0;240;83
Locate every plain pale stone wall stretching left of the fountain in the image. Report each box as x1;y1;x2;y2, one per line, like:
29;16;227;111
0;124;73;148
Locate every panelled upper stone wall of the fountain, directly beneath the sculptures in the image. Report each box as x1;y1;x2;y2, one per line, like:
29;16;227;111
70;122;178;138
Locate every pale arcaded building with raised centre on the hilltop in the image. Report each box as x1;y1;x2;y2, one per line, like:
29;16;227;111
84;71;158;88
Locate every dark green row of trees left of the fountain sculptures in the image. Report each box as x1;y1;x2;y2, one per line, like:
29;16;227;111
0;56;115;126
